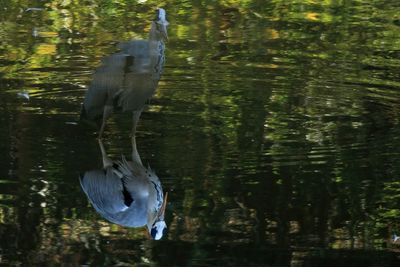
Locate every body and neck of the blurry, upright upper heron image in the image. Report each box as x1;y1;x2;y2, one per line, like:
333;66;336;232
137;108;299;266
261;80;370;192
81;11;168;138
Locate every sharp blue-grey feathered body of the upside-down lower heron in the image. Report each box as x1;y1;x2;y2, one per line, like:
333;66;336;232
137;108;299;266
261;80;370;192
80;154;164;227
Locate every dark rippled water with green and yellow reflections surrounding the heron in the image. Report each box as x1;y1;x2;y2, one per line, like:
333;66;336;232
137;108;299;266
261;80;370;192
0;0;400;266
